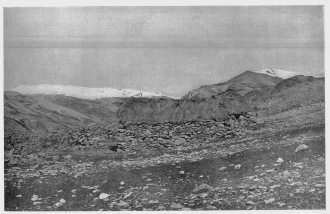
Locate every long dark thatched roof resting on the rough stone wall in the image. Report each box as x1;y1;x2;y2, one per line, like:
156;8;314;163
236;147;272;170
117;90;250;124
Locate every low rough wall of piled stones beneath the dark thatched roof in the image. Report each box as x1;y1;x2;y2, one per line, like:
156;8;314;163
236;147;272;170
64;112;258;150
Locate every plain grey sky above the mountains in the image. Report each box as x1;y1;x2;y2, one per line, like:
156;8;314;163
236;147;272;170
4;6;324;96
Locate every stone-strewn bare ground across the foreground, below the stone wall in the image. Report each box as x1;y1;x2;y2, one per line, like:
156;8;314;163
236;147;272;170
5;123;325;211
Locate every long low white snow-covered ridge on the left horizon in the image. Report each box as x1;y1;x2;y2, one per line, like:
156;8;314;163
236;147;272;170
9;84;178;99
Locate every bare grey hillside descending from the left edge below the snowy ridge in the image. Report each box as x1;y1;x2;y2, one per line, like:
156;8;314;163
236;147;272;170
4;92;92;132
